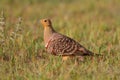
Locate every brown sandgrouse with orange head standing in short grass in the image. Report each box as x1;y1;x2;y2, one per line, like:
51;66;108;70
40;19;94;60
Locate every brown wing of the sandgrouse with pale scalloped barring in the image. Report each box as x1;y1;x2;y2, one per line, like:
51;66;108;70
47;34;93;55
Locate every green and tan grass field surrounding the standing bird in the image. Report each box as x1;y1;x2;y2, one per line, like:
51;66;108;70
0;0;120;80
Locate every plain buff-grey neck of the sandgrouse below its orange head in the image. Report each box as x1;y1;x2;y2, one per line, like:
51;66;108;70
44;26;55;44
